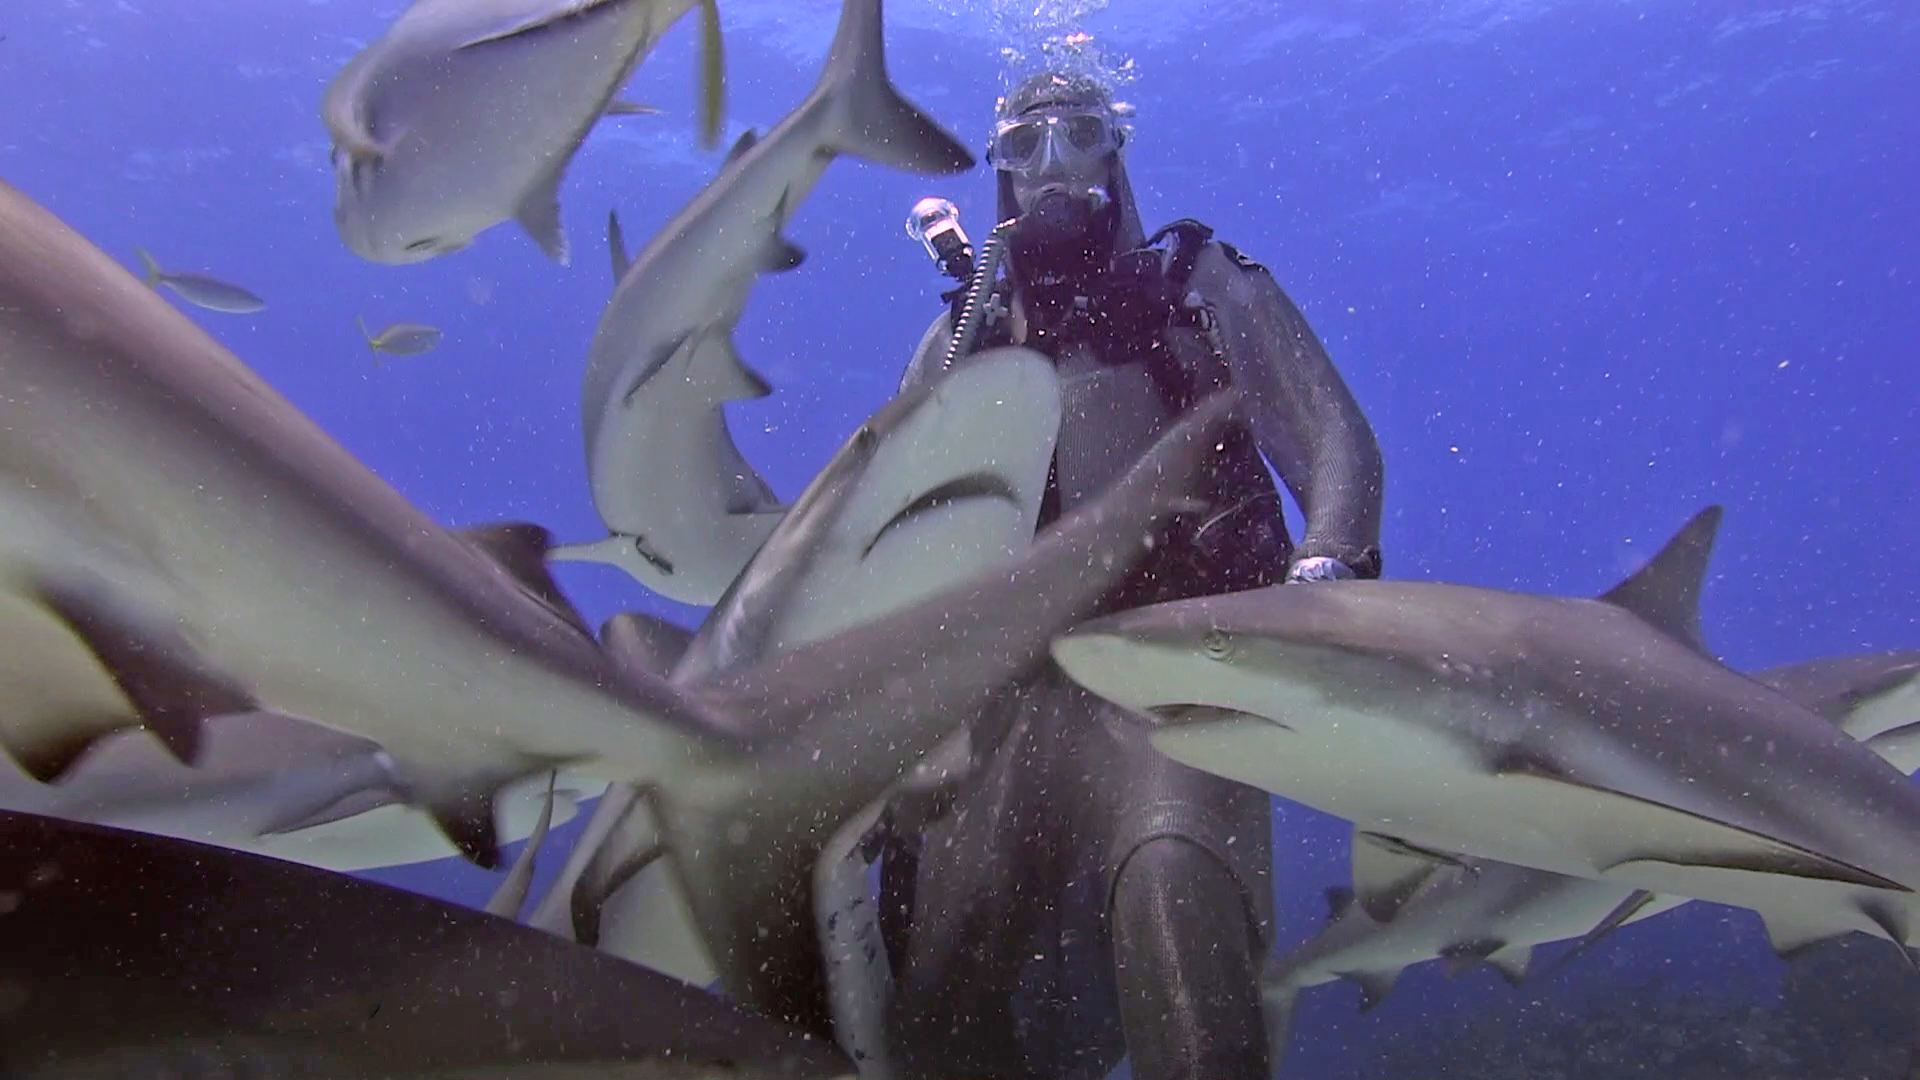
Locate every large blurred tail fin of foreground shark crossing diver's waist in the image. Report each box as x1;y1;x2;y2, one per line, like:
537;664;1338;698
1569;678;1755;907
625;354;1235;1034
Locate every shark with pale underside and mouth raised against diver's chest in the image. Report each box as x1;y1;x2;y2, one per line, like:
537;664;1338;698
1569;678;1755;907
530;352;1060;982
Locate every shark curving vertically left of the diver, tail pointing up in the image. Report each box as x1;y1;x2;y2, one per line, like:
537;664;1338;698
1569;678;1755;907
555;0;973;605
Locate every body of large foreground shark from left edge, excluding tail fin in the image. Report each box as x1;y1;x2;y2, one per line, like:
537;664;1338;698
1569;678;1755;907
0;176;747;865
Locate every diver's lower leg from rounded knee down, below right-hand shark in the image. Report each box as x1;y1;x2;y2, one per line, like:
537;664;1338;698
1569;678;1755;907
1110;836;1269;1080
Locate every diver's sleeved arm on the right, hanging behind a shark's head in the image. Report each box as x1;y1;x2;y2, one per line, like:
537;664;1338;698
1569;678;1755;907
1192;246;1386;578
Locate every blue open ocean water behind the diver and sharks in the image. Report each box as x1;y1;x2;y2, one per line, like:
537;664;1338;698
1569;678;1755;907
0;0;1920;1076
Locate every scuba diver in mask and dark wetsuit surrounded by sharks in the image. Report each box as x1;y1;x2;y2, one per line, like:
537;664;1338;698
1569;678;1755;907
876;73;1382;1080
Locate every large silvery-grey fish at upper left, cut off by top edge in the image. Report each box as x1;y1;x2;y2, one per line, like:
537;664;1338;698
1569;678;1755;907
321;0;720;263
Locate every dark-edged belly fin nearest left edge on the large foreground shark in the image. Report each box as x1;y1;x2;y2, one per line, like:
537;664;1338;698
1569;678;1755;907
23;577;259;778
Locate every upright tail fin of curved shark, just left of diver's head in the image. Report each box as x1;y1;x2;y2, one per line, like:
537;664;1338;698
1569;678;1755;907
814;0;973;175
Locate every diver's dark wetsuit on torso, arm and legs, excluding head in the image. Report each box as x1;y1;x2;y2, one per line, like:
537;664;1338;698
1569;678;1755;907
881;220;1382;1080
